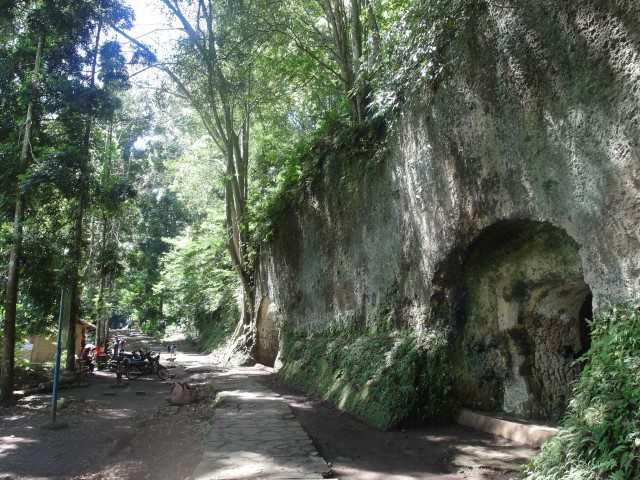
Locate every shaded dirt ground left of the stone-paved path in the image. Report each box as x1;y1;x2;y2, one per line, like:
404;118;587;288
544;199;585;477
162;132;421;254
0;339;212;480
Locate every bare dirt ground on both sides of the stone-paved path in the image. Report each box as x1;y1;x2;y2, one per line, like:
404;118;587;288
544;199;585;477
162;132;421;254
0;333;533;480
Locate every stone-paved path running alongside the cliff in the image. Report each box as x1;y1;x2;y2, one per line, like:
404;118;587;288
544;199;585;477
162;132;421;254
178;354;330;480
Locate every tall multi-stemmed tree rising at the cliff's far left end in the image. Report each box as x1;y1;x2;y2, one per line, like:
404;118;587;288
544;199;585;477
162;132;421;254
116;0;278;352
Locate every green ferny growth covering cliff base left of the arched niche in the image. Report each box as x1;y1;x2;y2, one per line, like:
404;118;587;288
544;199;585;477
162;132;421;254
278;328;451;428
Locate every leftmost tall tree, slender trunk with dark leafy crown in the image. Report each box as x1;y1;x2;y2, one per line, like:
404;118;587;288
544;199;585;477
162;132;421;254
2;0;112;400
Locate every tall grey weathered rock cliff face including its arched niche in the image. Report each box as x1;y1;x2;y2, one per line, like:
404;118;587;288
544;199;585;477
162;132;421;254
256;0;640;419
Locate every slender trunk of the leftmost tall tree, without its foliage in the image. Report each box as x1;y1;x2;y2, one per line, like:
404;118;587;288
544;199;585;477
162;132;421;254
0;35;44;405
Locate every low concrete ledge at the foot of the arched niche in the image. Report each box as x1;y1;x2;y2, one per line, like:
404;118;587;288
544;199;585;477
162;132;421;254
457;408;558;448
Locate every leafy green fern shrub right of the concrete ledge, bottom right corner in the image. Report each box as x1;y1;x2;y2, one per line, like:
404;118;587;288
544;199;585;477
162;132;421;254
525;295;640;480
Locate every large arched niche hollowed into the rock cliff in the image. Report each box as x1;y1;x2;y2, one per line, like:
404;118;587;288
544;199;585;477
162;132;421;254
452;221;592;421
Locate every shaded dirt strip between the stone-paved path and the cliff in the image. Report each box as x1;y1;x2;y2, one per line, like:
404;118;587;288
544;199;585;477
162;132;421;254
254;370;534;480
